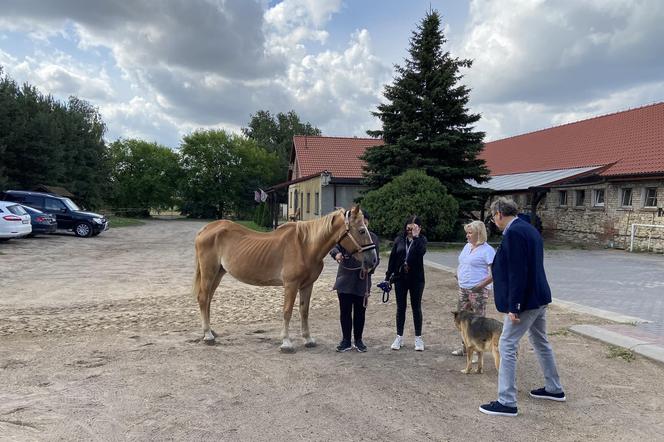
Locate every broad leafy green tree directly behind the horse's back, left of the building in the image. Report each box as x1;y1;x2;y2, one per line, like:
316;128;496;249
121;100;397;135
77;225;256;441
180;130;278;218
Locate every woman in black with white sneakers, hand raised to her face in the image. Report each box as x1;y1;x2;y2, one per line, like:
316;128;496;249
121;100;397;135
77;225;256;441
385;215;427;351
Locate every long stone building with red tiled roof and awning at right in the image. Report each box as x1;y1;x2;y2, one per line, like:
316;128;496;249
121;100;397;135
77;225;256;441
478;103;664;251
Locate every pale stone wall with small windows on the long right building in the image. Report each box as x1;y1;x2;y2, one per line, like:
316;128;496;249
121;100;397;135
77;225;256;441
490;180;664;253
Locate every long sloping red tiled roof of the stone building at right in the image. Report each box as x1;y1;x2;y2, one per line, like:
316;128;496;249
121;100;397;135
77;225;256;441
480;103;664;176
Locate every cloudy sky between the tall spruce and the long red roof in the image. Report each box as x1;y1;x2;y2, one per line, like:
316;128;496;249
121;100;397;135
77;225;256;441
455;0;664;141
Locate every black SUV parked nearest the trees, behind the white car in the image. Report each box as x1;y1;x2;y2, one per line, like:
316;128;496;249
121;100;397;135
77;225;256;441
0;190;108;237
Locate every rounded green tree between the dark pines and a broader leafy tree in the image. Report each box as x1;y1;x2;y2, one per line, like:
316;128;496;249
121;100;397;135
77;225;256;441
108;139;181;216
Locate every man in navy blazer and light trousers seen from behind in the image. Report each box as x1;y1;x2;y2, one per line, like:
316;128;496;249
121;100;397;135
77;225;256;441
480;198;566;416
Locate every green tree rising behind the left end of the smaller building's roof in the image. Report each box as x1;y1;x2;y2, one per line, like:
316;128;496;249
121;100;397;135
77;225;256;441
242;110;321;184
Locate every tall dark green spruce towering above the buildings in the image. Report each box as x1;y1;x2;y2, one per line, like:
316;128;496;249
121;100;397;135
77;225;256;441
363;11;488;210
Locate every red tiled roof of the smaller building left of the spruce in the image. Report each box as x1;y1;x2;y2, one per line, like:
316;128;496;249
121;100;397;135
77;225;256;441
292;135;384;179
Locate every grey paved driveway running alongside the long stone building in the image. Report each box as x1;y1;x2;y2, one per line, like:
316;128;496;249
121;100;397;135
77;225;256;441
425;250;664;338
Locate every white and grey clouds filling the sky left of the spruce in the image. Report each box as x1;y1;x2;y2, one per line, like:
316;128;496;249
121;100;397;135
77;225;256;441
0;0;391;145
